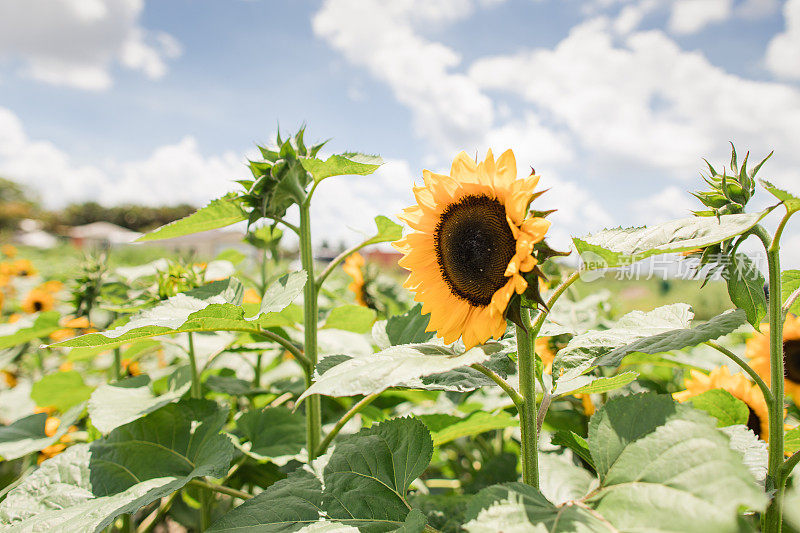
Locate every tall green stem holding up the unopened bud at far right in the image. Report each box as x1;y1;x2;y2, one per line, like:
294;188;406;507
754;223;788;533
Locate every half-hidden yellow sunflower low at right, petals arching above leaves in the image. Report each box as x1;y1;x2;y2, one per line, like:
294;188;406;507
672;365;769;440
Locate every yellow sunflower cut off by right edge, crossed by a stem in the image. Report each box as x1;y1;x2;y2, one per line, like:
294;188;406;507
745;315;800;407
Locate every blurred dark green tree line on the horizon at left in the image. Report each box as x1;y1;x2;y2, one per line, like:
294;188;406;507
0;178;196;232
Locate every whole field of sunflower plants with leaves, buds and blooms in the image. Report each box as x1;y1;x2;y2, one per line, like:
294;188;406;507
0;130;800;533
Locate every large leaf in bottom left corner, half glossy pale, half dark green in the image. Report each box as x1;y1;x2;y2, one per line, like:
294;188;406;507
0;400;234;533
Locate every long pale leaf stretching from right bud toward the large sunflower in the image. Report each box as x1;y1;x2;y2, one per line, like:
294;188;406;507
572;210;770;270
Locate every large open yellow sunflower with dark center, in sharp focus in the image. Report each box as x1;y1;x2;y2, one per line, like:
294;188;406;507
394;150;550;348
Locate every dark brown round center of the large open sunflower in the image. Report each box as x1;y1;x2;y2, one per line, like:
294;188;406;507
434;196;516;306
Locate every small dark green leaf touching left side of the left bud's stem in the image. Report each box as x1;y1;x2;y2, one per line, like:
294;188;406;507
234;407;306;461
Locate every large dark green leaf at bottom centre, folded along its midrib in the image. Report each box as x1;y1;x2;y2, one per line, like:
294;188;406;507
209;418;433;533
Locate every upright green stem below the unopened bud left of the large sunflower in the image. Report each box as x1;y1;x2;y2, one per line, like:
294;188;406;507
300;202;322;461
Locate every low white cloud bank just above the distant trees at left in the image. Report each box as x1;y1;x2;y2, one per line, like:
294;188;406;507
0;108;241;207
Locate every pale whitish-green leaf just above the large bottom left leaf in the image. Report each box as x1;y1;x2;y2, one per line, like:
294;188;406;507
89;366;192;433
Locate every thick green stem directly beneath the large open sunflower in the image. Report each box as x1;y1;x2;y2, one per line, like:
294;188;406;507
517;307;539;488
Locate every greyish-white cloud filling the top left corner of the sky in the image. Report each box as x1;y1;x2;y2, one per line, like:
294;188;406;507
0;0;181;90
